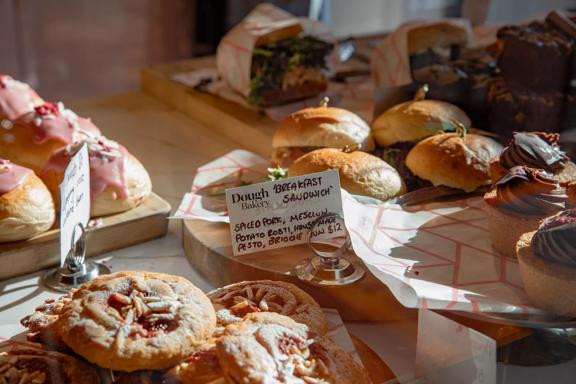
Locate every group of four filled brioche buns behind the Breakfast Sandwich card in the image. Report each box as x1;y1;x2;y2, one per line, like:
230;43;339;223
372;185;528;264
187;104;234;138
272;89;502;201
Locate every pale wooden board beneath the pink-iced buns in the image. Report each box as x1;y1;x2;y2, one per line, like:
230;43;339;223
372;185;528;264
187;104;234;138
0;193;171;280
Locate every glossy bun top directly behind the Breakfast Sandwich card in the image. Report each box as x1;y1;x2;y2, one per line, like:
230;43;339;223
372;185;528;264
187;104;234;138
288;148;406;201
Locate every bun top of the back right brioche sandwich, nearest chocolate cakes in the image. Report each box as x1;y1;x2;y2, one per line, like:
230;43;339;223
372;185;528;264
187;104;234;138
372;100;471;147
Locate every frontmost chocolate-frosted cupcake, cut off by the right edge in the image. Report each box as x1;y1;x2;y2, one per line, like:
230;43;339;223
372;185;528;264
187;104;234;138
516;210;576;316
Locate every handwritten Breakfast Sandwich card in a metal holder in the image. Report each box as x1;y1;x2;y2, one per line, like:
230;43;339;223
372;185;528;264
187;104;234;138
226;171;343;255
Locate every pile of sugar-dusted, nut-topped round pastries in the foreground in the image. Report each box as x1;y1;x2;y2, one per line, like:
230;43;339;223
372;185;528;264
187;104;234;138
20;271;370;384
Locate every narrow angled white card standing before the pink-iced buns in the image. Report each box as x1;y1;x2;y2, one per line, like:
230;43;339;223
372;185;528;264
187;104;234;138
60;144;90;266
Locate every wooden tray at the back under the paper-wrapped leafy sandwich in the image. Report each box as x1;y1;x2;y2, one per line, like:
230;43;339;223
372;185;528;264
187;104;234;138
140;56;276;156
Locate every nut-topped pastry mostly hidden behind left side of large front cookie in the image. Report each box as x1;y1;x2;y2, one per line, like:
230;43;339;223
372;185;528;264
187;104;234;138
20;289;76;351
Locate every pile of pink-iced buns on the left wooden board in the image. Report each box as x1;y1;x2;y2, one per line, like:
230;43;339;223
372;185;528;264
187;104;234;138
0;75;151;242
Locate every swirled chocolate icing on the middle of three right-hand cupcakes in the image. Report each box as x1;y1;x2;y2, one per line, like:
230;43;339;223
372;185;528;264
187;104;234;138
496;166;568;216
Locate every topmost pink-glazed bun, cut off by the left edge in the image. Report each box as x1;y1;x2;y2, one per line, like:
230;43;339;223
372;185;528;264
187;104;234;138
0;74;43;122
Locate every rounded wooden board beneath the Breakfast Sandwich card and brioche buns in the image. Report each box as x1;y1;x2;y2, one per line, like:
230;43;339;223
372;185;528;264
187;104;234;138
182;220;530;346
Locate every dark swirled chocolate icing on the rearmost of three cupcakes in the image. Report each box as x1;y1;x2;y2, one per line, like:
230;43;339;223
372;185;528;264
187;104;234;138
500;132;568;172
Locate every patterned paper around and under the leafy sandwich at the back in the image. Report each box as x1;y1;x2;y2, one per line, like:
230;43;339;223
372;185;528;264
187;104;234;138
172;4;374;122
